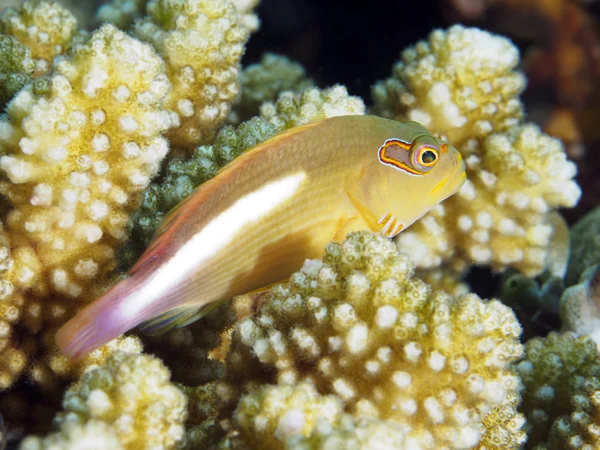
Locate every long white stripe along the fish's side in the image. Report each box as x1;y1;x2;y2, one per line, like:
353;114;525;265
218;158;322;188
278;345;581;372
120;172;307;319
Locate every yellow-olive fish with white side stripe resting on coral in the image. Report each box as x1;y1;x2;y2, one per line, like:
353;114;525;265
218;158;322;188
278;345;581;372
56;115;466;360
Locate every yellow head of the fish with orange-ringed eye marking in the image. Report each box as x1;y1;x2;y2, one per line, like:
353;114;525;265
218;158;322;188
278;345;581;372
364;122;466;237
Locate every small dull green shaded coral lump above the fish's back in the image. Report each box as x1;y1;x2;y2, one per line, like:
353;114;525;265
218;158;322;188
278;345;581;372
230;53;313;123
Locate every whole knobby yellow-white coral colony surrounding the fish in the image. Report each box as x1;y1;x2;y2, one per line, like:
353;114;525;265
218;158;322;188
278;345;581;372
0;0;600;450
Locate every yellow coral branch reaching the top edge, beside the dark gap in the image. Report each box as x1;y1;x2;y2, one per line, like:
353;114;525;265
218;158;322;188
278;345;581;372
133;0;249;151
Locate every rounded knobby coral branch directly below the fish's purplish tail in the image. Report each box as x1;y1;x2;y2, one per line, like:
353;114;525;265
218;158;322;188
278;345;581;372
56;352;187;450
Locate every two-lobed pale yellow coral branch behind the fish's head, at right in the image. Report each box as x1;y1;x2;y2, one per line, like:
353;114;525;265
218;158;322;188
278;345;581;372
373;26;580;276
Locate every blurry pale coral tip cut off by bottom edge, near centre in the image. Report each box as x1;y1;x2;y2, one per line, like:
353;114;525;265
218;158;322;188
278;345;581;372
285;414;410;450
